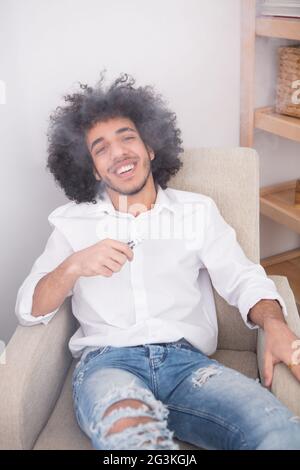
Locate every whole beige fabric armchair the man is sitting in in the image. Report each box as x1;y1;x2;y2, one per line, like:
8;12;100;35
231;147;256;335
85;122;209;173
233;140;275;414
0;148;300;449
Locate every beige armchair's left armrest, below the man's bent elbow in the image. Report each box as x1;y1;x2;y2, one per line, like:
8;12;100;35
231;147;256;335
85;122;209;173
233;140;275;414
0;297;77;449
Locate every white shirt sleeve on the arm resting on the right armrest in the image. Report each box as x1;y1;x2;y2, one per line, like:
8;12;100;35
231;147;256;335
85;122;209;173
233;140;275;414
200;198;287;329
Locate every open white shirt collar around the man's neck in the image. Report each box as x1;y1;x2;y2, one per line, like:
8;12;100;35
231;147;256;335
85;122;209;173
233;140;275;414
92;185;175;218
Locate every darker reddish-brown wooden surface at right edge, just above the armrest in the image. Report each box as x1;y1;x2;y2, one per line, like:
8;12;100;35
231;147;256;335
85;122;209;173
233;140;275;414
260;249;300;309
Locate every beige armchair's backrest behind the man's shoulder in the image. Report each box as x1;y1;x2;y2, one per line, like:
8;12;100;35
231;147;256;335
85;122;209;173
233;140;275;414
168;147;260;351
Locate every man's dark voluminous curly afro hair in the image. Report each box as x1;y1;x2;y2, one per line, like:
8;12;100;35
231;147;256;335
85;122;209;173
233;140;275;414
47;73;183;204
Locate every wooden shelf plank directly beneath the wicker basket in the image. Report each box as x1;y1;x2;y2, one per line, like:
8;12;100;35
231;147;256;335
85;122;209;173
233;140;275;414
254;106;300;142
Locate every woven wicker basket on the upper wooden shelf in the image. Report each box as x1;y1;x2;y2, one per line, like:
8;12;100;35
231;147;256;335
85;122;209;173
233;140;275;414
275;46;300;118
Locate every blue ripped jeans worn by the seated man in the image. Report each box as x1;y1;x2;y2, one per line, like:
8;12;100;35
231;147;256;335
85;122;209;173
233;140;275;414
73;338;300;450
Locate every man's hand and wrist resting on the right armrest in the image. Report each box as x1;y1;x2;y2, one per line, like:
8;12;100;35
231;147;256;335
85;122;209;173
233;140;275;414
248;299;300;387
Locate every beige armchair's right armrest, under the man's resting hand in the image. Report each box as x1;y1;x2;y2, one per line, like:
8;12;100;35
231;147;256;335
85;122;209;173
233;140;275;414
257;276;300;415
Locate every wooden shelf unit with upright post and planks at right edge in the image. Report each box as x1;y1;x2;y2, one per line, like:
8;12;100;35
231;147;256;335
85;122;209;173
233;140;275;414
240;0;300;313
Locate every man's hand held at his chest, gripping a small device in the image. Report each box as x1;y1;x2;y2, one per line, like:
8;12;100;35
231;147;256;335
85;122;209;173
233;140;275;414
70;238;133;277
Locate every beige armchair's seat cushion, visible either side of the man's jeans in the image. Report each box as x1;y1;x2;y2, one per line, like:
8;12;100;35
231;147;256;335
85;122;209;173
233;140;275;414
34;350;258;450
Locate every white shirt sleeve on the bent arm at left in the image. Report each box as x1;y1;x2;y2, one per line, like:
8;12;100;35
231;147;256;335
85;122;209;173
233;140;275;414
15;227;73;326
